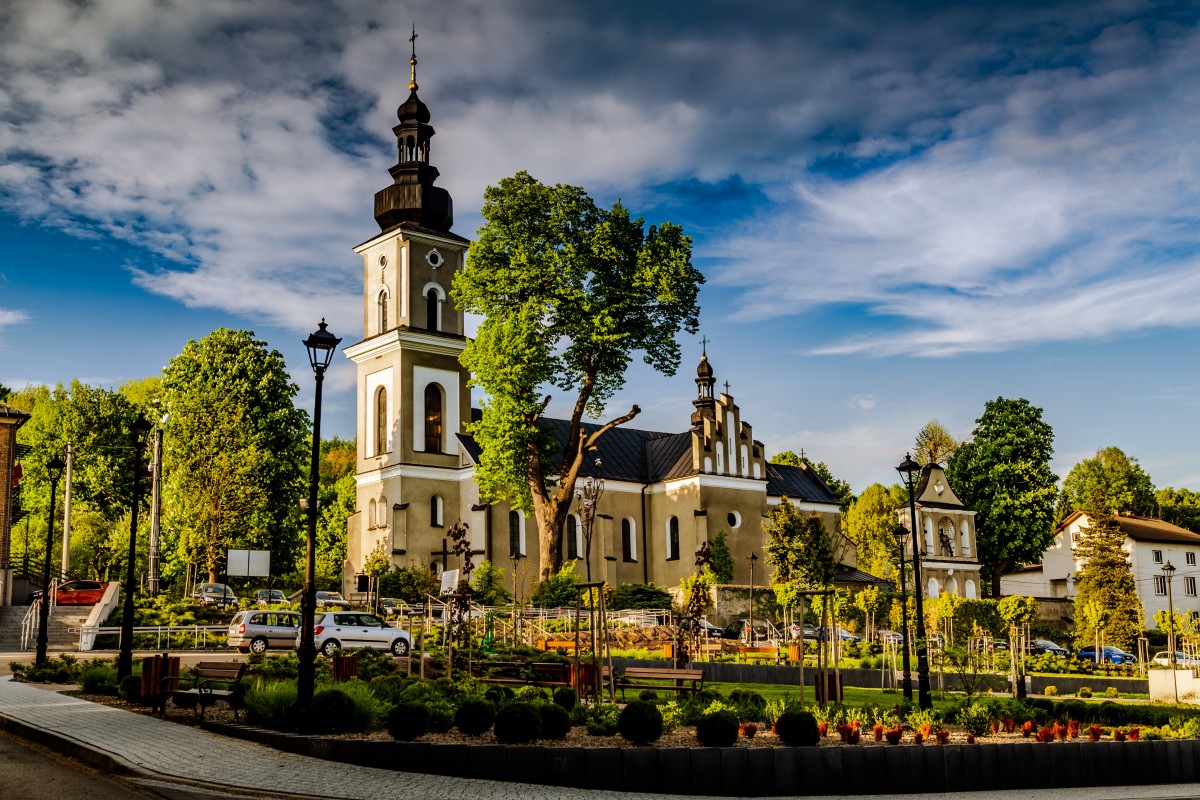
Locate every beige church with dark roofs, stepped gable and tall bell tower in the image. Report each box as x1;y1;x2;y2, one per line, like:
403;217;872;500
343;53;870;599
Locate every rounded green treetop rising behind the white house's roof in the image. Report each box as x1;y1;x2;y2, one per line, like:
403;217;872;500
1055;447;1158;524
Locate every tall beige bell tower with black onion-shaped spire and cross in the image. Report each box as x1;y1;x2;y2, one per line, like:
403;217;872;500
343;29;470;591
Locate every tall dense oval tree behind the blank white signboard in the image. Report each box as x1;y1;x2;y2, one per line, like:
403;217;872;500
162;329;310;581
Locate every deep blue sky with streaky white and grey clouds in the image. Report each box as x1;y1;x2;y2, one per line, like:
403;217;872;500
0;0;1200;491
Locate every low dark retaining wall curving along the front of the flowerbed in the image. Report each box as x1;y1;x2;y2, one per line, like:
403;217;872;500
200;722;1200;798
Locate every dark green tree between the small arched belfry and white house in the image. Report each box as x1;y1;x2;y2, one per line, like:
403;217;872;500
946;397;1058;597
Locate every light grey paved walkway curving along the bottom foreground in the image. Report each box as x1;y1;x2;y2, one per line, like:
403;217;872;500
0;679;1200;800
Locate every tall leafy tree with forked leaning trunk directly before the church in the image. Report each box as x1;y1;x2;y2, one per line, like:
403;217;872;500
454;172;703;581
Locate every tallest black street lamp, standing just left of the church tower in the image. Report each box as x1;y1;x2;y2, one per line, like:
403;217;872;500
296;319;342;714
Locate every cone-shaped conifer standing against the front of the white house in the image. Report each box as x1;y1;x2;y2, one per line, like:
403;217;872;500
1075;494;1142;648
